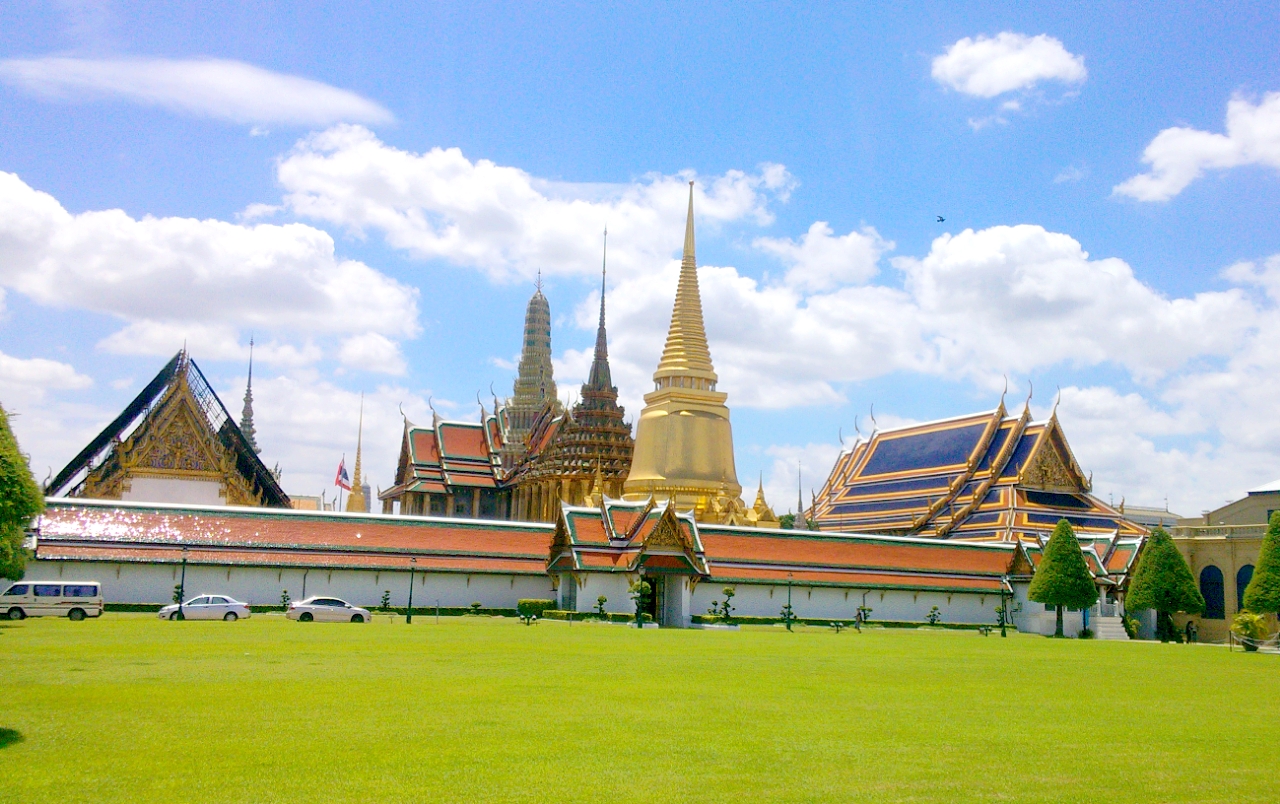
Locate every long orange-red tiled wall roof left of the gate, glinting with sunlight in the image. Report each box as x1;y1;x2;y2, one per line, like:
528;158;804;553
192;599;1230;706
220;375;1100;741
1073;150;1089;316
36;498;552;575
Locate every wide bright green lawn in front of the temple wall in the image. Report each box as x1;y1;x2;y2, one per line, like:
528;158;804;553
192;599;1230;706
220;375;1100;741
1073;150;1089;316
0;615;1280;804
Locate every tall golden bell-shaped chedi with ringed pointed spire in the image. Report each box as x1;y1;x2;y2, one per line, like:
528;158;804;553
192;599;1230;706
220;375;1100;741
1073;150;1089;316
623;182;745;522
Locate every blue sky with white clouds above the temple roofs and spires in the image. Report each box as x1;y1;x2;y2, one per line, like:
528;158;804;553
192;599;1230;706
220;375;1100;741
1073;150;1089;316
0;3;1280;513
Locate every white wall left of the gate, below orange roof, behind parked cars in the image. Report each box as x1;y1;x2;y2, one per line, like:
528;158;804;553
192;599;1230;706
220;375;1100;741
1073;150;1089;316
26;559;555;608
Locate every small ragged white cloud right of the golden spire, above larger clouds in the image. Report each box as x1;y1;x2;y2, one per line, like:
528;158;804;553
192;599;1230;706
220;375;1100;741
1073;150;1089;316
753;220;893;291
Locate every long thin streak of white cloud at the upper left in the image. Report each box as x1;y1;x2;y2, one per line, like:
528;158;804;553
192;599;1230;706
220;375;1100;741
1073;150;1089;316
0;56;394;125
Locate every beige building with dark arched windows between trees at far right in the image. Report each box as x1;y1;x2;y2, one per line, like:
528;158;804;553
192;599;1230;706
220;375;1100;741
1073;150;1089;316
1171;480;1280;641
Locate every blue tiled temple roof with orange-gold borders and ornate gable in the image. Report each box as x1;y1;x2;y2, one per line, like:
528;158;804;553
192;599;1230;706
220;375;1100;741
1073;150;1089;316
812;403;1146;543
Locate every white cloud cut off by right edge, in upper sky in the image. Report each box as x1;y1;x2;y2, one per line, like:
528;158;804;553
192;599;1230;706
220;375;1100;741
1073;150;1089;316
1114;92;1280;201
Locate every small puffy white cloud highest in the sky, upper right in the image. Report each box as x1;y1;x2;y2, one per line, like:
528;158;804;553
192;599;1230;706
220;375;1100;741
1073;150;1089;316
932;31;1088;102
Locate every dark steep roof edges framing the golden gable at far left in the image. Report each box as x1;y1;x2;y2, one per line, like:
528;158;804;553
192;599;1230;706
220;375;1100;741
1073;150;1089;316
45;351;289;508
